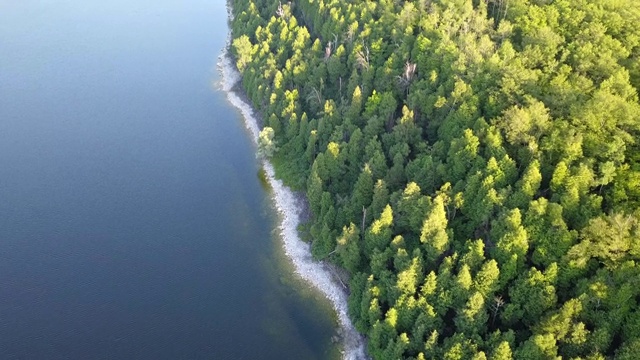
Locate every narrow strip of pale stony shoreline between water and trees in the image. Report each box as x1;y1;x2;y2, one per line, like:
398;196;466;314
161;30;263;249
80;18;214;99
218;48;368;360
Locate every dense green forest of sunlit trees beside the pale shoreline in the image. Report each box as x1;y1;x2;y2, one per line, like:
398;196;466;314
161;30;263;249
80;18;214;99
230;0;640;359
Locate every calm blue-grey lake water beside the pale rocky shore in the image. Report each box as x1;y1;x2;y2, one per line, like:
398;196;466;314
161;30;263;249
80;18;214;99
0;0;335;359
